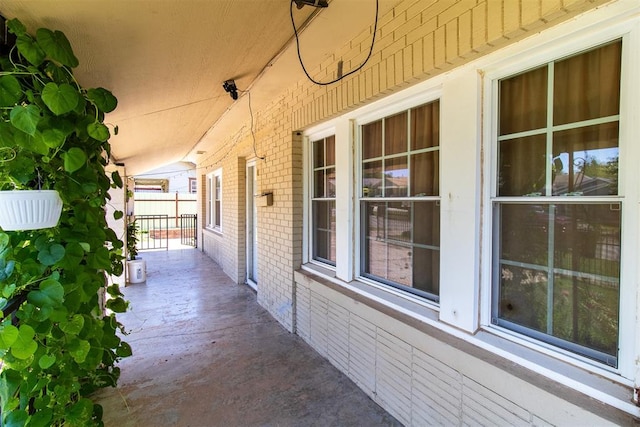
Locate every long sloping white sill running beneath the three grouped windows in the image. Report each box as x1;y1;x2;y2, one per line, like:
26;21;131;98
298;264;640;424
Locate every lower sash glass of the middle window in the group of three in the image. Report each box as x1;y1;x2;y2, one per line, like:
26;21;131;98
361;202;440;296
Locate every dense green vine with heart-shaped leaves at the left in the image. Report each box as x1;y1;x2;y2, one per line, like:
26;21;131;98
0;19;131;426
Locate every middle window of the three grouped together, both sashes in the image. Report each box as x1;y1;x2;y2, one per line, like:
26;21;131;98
359;100;440;301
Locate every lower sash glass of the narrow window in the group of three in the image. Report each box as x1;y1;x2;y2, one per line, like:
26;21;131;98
312;200;336;265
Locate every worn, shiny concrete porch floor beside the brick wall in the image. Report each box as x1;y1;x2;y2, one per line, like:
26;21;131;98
95;249;400;427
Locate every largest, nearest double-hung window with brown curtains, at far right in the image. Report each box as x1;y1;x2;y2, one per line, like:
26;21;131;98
492;41;623;367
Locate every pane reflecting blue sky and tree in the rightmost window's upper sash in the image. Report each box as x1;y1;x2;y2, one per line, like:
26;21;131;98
553;122;619;196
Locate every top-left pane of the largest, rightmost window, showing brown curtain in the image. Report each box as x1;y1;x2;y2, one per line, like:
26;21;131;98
498;66;547;135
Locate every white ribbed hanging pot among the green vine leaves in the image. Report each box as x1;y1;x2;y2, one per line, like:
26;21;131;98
0;190;62;231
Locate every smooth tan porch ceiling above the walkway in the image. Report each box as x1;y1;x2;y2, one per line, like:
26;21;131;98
0;0;399;175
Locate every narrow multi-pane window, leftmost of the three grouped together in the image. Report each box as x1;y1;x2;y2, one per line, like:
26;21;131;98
311;135;336;266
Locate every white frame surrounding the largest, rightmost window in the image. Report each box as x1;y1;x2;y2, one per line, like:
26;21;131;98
481;16;640;380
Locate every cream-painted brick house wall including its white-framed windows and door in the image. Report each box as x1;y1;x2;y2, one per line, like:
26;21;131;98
197;0;640;425
